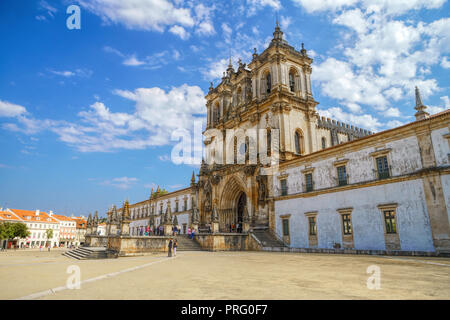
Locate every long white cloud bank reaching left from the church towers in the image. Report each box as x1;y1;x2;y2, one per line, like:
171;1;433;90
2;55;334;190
2;84;206;152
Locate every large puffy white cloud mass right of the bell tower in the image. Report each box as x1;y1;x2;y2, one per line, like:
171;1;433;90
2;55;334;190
308;0;450;128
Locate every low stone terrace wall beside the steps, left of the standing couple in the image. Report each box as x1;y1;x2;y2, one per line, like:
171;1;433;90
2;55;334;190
108;236;170;257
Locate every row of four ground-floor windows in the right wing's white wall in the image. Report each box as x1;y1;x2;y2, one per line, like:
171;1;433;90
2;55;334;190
282;209;397;236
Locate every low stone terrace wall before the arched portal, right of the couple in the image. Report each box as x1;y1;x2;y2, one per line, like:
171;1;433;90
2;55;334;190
194;233;251;251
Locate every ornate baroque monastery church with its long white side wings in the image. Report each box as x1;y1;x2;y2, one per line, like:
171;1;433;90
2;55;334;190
102;24;450;253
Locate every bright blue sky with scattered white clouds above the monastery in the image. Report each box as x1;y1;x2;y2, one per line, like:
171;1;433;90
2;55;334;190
0;0;450;215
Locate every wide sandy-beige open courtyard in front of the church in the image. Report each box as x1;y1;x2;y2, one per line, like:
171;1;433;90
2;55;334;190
0;250;450;299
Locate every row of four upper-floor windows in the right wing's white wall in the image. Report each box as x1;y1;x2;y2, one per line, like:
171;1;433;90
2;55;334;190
280;156;391;196
